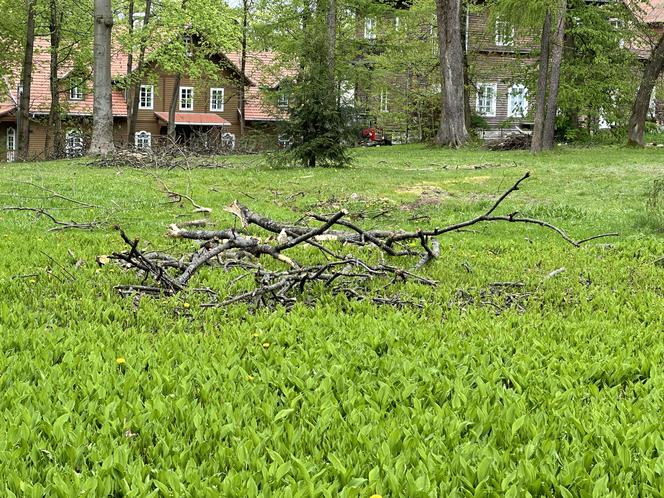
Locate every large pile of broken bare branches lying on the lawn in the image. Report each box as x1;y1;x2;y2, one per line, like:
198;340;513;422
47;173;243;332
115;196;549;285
112;173;616;307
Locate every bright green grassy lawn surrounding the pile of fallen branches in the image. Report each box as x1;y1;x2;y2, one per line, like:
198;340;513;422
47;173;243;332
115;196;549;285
0;146;664;497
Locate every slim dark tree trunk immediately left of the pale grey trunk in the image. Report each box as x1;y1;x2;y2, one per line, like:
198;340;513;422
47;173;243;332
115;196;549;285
44;0;63;159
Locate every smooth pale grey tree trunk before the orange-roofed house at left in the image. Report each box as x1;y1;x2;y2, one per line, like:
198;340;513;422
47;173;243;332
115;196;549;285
90;0;115;155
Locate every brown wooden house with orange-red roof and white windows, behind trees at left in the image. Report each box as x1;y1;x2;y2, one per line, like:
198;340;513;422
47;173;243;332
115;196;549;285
0;38;283;161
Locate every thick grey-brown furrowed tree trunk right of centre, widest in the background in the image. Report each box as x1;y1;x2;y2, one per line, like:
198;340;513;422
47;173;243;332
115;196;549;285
436;0;468;147
